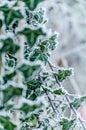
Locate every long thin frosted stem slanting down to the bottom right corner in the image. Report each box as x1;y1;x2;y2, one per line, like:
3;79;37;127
48;61;86;130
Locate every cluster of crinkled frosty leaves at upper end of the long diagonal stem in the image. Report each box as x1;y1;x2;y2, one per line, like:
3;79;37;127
30;35;56;64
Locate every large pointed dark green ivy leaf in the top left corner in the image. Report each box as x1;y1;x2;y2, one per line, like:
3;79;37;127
0;5;23;26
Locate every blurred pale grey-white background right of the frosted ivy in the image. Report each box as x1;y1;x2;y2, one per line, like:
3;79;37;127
39;0;86;95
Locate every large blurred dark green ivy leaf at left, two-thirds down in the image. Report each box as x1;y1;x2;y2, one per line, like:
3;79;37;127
3;85;22;103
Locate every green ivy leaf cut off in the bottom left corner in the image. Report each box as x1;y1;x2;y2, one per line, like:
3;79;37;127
0;116;16;130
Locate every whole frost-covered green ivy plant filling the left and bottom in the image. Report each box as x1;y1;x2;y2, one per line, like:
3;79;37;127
0;0;86;130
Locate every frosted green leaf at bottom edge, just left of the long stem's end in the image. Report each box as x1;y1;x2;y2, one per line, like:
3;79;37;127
60;119;75;130
